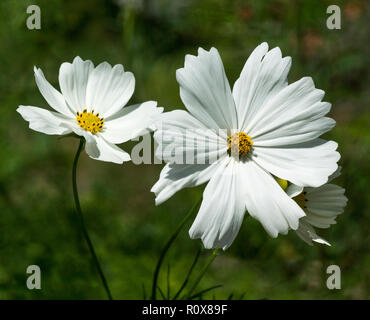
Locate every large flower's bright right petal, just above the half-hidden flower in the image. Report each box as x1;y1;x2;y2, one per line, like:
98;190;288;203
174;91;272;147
252;139;340;187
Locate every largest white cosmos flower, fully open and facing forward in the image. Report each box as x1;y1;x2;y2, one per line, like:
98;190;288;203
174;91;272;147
152;43;340;249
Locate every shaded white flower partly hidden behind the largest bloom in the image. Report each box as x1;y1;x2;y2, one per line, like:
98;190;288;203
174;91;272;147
286;167;348;246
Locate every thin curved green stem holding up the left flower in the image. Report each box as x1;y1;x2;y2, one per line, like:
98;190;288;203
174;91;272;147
72;138;113;300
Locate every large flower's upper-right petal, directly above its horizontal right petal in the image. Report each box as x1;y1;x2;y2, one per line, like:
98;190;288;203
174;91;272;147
250;77;335;147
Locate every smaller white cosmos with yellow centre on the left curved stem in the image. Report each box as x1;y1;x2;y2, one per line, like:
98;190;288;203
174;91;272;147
17;57;163;163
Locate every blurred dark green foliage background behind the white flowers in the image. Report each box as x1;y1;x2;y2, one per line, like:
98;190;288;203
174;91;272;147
0;0;370;299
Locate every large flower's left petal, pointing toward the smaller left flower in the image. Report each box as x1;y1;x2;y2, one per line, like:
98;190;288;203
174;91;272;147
154;110;228;164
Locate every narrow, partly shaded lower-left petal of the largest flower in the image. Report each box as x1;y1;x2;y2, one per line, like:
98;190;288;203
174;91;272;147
150;156;229;205
